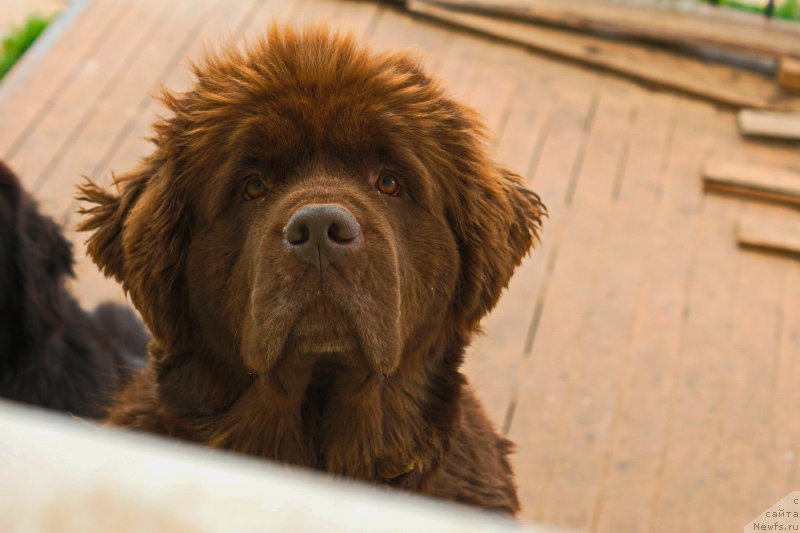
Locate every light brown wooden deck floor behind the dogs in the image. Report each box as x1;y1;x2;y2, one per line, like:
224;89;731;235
0;0;800;533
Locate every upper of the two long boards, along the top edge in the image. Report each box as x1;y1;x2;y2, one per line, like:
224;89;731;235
434;0;800;58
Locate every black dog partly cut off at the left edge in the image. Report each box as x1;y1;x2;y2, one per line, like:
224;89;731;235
0;162;149;418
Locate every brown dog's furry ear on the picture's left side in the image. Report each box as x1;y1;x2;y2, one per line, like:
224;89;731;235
78;157;190;345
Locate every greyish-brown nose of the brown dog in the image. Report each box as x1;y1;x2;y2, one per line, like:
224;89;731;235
283;204;361;270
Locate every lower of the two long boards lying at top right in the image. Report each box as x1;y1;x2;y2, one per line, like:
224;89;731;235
408;0;800;110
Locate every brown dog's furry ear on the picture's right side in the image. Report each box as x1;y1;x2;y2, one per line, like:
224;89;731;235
456;165;547;327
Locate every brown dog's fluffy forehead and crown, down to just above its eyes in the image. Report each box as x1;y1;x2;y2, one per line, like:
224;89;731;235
174;30;484;220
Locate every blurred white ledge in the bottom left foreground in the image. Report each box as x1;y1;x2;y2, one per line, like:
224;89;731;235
0;402;564;533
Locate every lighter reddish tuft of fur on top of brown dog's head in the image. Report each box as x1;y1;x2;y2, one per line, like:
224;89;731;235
188;31;454;157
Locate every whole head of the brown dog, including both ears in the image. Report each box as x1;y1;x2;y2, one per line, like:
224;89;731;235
83;30;543;375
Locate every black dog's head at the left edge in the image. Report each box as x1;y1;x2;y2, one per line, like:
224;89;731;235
0;162;72;353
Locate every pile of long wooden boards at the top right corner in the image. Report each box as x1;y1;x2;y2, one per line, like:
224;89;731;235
405;0;800;112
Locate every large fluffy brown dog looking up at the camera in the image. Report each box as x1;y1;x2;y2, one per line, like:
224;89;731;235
80;28;543;513
